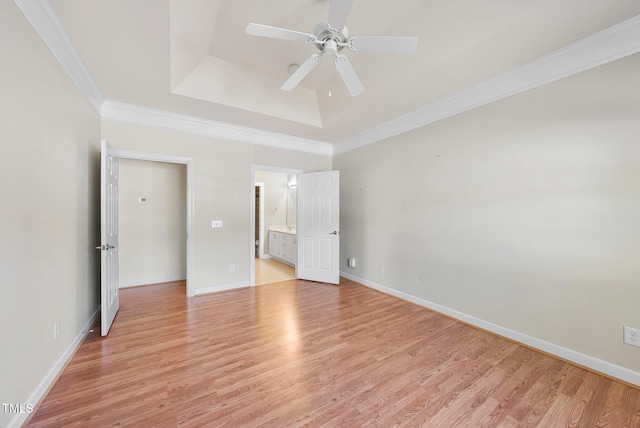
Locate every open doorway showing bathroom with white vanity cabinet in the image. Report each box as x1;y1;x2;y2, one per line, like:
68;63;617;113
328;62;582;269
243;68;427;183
251;165;302;285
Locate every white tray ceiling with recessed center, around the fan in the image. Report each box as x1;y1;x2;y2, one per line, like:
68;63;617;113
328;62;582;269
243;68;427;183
21;0;640;152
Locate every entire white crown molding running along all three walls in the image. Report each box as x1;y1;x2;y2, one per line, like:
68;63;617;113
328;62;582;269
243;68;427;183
14;0;640;156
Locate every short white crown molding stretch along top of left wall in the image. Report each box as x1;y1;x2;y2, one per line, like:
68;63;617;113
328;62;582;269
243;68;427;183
14;0;104;114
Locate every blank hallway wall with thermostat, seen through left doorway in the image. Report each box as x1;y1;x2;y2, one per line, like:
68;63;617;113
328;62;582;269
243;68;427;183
118;159;187;287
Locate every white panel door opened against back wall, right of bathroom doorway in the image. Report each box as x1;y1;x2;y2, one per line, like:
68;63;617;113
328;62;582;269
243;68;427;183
296;171;340;284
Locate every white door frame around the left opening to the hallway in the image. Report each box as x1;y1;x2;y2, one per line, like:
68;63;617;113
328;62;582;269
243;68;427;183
116;149;194;297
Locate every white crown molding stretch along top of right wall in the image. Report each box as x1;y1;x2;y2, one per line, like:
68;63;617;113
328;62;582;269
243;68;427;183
333;15;640;155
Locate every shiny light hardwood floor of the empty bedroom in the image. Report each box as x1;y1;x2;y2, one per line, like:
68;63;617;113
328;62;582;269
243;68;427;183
28;279;640;428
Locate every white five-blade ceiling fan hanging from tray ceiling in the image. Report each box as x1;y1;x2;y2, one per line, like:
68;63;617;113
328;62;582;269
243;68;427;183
246;0;418;97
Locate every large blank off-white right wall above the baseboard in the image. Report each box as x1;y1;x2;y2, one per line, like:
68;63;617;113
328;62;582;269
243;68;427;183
334;51;640;382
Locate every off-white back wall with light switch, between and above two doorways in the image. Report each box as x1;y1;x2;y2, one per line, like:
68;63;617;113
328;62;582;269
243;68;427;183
102;120;331;294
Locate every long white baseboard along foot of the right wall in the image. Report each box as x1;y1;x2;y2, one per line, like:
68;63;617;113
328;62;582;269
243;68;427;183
340;272;640;386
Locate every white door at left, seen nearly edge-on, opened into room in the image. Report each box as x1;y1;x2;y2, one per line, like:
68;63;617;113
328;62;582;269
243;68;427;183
96;140;120;336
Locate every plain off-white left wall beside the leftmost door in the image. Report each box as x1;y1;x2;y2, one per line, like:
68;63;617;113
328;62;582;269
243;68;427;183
0;1;100;426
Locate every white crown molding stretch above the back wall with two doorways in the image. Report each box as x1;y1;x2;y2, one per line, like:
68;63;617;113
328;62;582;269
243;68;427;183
100;100;333;156
